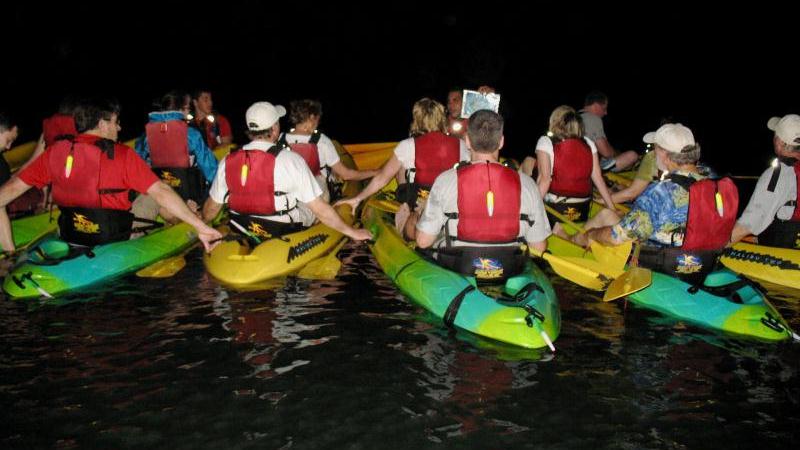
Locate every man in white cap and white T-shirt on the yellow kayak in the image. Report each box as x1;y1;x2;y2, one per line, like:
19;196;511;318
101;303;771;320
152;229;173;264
203;102;372;243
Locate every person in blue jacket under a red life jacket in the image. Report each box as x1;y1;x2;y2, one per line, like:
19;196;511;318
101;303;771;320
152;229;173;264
136;91;217;209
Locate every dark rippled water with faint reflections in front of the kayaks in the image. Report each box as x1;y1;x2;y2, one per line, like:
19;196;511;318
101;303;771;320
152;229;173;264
0;244;800;449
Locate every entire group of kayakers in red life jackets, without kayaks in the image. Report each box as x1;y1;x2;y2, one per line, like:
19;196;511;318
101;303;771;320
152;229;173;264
0;87;800;286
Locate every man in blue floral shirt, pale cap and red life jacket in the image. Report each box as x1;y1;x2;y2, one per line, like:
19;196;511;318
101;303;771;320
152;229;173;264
572;124;739;283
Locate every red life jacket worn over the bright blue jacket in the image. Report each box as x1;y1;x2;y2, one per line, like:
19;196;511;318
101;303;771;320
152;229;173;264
145;120;189;168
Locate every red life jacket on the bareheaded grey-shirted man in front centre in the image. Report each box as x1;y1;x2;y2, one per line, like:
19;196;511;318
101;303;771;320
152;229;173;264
456;162;522;243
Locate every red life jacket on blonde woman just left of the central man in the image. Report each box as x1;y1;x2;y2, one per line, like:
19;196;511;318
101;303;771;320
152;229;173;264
414;131;461;186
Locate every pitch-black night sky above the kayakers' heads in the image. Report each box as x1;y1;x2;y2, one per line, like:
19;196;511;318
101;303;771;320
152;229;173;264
0;1;800;174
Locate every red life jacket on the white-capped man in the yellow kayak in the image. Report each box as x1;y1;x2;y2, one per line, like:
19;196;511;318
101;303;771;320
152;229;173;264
225;145;285;216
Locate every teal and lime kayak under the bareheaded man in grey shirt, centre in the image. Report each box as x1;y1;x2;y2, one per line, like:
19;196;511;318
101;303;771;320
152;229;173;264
362;199;561;349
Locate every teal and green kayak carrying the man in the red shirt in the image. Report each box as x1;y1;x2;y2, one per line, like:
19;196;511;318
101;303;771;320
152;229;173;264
3;223;197;299
